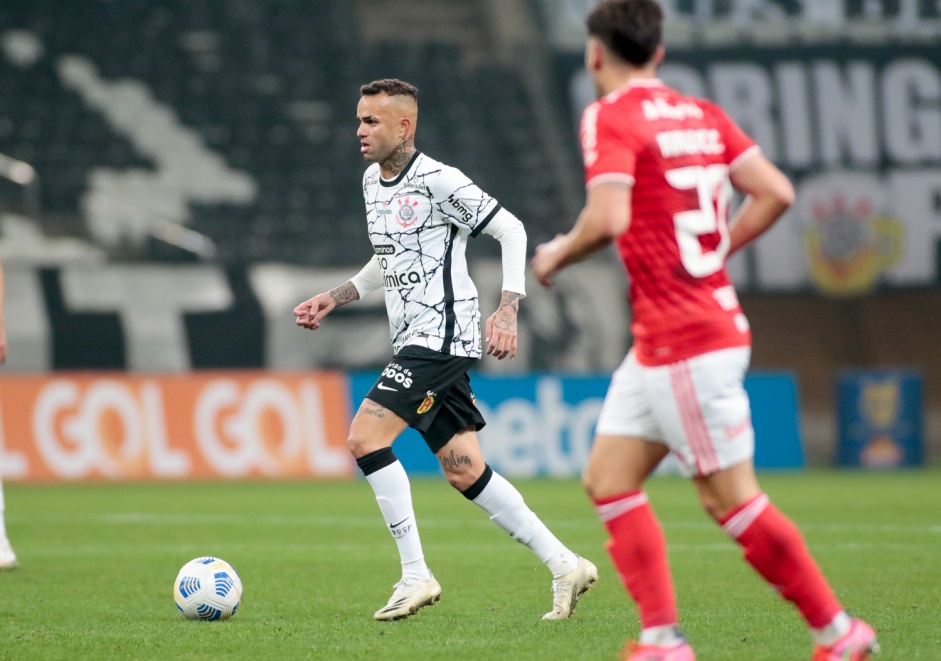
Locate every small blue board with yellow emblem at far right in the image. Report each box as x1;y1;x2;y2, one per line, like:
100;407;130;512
837;369;924;469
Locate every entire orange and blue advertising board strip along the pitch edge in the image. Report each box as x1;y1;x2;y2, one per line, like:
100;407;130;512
0;371;803;482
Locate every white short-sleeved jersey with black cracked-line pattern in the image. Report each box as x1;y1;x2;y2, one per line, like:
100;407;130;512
363;152;500;358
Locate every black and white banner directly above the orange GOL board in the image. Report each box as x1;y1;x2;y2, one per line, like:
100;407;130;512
2;258;630;374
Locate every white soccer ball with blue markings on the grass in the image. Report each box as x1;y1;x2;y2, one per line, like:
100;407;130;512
173;556;242;620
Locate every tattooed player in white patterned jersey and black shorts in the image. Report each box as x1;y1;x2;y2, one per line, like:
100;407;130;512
294;79;598;620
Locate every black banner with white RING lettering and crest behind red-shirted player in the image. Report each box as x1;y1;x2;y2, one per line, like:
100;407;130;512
557;40;941;296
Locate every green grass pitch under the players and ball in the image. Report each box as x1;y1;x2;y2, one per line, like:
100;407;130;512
0;469;941;661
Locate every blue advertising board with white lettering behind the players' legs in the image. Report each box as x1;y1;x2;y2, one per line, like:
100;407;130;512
350;372;804;477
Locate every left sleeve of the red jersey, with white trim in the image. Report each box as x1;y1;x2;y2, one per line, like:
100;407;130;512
580;101;639;187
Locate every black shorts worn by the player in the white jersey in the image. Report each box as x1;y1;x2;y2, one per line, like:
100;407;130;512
366;346;487;453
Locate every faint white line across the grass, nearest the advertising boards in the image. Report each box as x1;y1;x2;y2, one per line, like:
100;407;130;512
16;512;941;535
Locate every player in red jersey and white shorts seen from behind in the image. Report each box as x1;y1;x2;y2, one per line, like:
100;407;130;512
532;0;876;661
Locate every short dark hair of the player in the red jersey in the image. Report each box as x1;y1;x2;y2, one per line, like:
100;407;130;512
585;0;663;66
